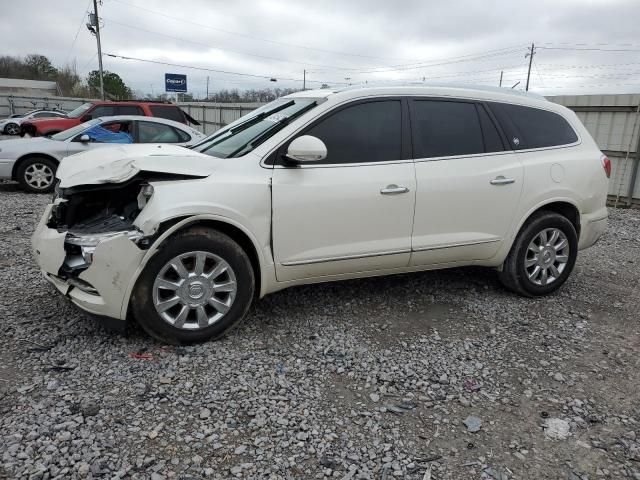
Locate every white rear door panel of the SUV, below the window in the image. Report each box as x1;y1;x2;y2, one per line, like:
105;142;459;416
411;152;524;265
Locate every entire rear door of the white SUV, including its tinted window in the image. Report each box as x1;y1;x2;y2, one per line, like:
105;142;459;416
410;99;523;266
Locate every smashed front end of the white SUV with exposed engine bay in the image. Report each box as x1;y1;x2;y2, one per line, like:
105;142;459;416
32;172;194;324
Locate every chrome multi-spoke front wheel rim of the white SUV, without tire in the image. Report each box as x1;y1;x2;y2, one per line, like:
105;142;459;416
153;251;238;330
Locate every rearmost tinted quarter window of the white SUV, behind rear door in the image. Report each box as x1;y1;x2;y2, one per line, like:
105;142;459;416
490;103;578;150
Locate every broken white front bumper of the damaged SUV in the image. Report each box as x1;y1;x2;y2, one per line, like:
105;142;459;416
31;205;146;320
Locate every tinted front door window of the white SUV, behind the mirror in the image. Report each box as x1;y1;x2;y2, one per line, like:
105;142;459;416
305;100;402;164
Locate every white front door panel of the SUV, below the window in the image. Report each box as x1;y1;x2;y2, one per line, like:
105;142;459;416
272;162;416;281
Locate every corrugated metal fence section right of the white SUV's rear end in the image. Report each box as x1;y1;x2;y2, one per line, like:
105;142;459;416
547;94;640;204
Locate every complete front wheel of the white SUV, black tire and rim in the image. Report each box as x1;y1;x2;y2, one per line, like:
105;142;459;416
131;227;255;345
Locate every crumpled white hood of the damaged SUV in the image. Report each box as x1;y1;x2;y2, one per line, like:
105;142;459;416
56;144;222;188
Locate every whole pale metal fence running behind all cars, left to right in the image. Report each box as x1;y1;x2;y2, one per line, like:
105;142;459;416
0;94;640;205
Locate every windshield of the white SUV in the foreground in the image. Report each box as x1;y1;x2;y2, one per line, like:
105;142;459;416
192;98;316;158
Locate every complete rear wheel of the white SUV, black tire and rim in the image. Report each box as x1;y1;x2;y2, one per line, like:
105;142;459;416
498;210;578;297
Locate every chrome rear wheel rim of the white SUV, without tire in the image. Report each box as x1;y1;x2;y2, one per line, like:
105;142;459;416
524;228;569;286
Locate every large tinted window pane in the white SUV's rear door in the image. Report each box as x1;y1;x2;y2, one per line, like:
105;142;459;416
411;100;484;158
